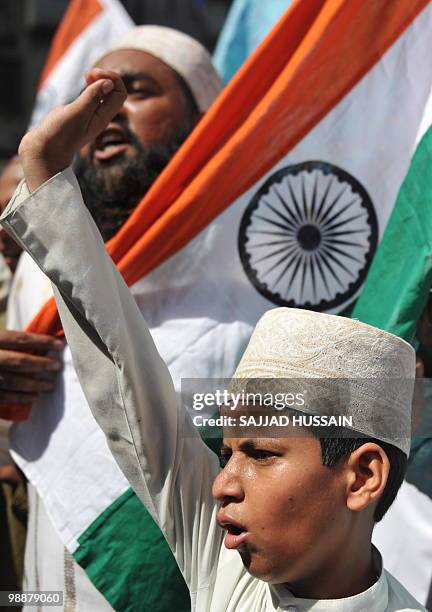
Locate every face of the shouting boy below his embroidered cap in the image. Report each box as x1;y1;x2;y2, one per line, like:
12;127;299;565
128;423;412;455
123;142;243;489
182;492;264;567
213;420;350;587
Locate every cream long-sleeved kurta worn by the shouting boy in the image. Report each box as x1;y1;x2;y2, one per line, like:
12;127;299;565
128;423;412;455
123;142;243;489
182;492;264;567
3;169;424;612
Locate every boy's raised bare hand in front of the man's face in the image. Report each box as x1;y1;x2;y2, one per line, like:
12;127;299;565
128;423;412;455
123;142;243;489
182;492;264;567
18;68;127;191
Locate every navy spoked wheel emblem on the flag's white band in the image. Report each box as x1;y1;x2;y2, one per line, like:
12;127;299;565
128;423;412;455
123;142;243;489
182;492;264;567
239;162;378;310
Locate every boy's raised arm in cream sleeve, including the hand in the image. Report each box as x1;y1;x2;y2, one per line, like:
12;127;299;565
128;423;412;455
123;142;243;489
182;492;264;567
2;71;222;593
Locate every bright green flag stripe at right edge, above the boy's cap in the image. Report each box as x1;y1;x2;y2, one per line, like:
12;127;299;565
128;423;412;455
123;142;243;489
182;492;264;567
351;128;432;342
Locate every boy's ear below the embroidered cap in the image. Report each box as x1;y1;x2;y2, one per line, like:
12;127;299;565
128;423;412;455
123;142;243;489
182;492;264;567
346;442;390;512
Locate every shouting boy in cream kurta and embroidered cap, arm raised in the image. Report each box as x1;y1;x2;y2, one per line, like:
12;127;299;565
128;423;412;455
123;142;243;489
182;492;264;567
2;70;424;612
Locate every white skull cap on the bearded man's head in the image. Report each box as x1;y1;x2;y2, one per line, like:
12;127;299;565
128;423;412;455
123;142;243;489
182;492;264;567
100;25;223;113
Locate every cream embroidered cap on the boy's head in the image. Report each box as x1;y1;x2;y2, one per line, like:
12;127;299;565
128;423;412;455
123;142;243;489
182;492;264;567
230;308;415;455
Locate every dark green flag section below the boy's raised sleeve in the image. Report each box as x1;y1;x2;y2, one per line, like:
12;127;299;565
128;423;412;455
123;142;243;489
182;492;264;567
73;489;190;612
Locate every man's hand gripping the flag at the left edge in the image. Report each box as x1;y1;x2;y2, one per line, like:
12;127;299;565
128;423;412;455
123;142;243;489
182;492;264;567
0;330;64;404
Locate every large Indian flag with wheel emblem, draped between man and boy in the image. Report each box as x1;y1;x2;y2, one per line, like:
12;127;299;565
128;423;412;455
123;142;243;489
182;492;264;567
5;0;432;610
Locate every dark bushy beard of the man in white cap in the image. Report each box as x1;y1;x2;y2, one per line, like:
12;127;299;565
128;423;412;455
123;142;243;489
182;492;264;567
74;126;187;241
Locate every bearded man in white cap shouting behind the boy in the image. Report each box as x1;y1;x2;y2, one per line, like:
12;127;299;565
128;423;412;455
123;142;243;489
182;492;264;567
0;26;221;612
